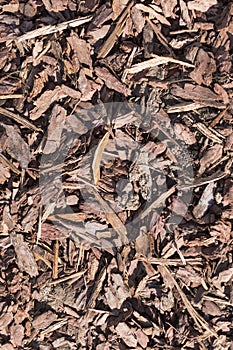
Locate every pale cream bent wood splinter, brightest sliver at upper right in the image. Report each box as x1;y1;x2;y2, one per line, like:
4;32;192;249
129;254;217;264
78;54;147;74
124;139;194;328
128;55;194;74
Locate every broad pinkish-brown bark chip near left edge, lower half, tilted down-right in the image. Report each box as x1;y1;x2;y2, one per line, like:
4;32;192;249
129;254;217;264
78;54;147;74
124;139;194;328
10;232;38;277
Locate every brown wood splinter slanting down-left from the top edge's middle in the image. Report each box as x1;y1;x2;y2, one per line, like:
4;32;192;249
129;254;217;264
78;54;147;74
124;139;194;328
98;1;134;58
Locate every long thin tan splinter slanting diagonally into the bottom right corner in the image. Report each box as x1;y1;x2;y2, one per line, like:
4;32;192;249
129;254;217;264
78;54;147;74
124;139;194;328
163;266;218;338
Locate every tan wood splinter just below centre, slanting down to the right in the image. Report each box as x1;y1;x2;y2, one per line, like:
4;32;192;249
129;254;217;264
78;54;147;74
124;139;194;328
93;190;128;244
